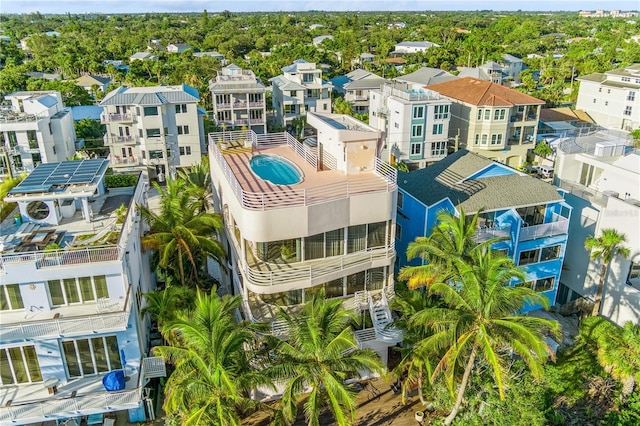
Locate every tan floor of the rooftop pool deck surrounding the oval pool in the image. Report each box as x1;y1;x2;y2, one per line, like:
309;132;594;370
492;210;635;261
224;145;387;193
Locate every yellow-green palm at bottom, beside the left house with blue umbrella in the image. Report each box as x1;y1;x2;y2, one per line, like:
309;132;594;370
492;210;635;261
153;292;268;426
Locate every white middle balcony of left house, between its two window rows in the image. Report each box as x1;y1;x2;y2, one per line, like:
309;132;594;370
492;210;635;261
0;290;131;342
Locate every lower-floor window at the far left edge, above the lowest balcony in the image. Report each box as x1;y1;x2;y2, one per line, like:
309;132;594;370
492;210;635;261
0;346;42;385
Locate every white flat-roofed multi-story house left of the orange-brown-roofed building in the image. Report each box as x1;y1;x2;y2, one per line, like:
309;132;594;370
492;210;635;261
369;83;452;168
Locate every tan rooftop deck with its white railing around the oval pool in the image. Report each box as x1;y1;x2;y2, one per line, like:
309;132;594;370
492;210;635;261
209;132;396;210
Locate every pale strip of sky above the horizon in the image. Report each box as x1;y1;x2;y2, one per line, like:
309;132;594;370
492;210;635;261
0;0;640;13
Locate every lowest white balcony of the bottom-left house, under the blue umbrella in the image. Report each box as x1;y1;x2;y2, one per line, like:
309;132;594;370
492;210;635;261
0;357;166;425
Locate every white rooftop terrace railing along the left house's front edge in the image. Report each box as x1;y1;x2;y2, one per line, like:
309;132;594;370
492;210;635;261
0;246;121;271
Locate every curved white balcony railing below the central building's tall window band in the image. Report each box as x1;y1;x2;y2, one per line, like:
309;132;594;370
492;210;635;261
245;244;395;286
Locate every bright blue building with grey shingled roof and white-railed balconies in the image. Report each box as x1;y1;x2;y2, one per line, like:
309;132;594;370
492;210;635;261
396;150;571;311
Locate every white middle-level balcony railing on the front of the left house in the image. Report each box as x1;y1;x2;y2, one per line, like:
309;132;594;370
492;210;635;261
0;290;131;342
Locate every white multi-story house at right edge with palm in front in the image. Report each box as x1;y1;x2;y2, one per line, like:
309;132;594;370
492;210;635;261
555;130;640;325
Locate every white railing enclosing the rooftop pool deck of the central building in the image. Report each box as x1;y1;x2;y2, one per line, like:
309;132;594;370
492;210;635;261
209;130;398;210
